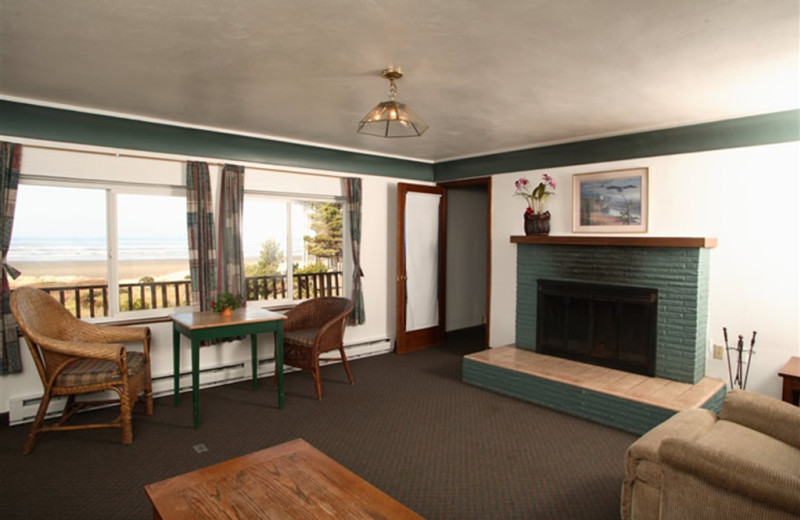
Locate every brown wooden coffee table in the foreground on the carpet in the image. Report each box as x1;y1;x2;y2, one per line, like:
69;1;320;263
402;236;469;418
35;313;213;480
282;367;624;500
144;439;422;520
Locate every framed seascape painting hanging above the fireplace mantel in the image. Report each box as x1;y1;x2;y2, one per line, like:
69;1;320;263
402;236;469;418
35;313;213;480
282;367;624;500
572;168;647;233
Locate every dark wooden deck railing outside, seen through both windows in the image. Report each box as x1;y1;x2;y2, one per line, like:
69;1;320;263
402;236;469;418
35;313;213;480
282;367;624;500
26;271;343;318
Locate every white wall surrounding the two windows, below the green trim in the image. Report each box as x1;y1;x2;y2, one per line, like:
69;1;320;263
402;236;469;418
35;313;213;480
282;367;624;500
0;137;432;413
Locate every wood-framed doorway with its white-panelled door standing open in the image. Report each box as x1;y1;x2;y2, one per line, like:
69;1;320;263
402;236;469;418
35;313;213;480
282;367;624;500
396;178;491;353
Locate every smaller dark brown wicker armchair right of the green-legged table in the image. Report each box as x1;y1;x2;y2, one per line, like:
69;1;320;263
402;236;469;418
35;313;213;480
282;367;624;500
283;297;354;400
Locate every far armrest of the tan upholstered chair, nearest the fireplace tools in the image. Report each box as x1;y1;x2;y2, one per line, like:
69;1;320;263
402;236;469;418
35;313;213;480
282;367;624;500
720;390;800;449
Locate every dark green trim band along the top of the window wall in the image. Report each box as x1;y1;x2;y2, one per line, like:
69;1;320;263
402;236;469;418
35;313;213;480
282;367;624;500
0;100;433;181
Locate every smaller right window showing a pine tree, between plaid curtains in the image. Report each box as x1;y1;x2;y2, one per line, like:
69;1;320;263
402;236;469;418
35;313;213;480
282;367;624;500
242;193;344;302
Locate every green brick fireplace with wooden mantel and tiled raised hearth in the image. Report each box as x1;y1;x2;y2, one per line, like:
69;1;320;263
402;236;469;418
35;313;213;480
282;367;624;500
462;236;726;434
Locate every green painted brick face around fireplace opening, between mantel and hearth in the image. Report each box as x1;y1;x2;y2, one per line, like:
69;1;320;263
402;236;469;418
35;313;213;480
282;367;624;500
516;244;710;383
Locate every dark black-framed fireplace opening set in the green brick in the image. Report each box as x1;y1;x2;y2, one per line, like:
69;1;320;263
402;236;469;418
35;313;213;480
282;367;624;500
536;279;658;376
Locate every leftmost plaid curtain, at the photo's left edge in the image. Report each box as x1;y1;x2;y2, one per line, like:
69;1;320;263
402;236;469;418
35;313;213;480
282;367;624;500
0;143;22;374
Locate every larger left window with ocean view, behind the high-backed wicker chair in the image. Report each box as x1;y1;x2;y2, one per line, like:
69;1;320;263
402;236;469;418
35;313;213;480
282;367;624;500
8;180;191;318
